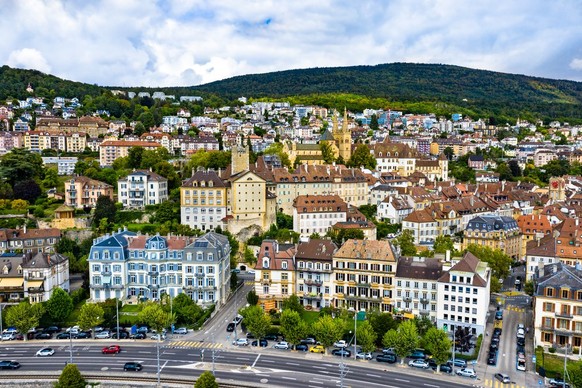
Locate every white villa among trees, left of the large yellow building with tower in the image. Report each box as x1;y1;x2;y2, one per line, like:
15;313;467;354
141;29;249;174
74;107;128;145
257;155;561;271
117;170;168;209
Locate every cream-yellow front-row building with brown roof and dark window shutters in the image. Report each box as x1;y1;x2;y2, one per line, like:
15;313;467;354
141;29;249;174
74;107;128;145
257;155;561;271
332;240;397;312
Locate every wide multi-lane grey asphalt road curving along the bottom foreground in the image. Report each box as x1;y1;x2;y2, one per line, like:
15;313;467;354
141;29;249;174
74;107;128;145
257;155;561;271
0;340;475;388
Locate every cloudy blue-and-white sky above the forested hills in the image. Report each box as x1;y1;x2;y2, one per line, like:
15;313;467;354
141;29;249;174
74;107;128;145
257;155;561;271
0;0;582;87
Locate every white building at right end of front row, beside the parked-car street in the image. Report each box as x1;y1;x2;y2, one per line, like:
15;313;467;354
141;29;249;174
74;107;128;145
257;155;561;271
437;252;491;336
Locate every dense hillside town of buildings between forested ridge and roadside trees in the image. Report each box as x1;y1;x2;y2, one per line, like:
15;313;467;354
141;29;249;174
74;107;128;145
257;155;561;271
0;85;582;388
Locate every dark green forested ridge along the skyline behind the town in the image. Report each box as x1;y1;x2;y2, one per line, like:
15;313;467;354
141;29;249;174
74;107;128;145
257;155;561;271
0;63;582;124
